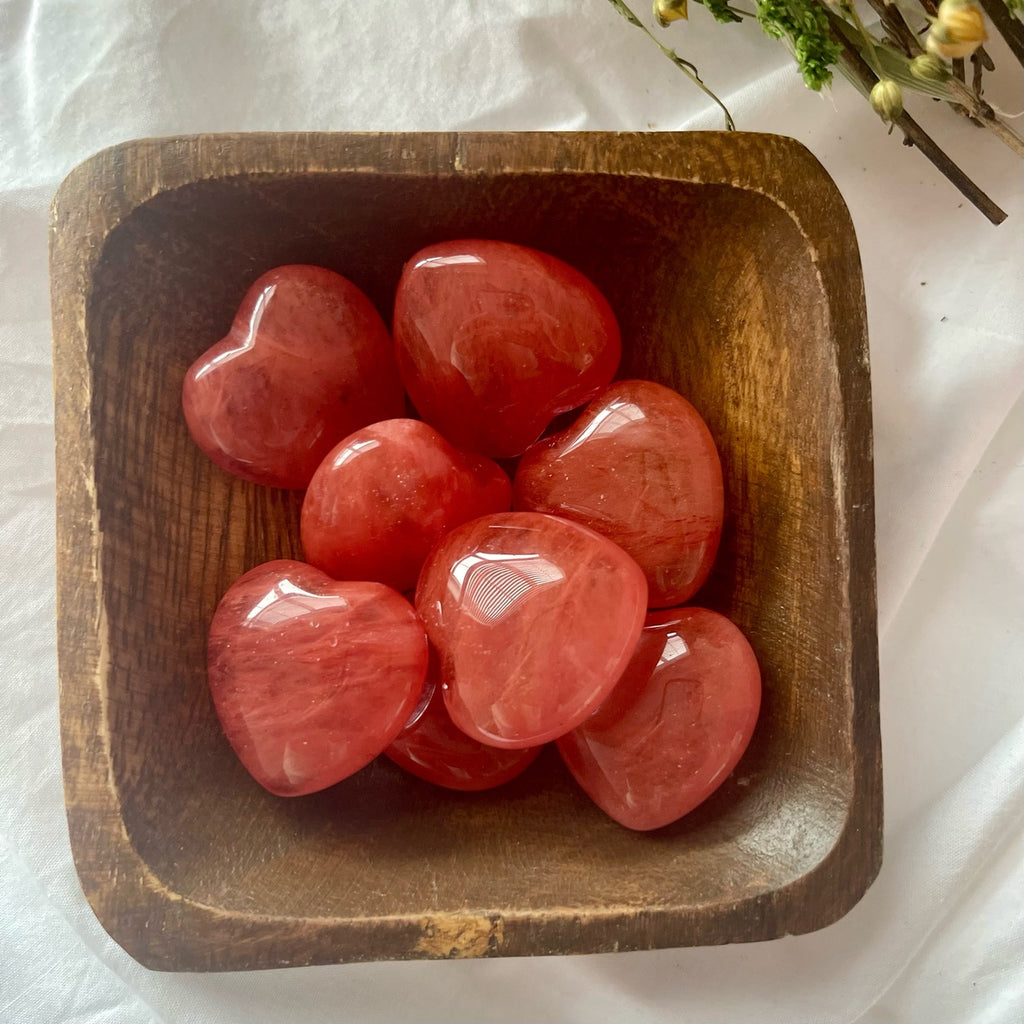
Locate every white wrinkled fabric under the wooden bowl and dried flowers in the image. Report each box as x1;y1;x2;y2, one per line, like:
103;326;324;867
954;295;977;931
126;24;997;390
0;0;1024;1024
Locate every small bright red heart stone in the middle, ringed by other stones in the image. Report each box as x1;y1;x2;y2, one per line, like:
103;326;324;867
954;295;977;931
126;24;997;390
302;420;512;591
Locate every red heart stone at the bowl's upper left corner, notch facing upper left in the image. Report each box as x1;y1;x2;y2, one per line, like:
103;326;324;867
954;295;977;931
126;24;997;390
181;264;406;488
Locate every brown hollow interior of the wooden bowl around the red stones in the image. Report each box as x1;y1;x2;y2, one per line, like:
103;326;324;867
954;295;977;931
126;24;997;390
86;171;853;919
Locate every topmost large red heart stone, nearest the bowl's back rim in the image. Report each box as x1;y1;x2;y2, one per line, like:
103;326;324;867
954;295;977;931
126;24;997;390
394;240;622;458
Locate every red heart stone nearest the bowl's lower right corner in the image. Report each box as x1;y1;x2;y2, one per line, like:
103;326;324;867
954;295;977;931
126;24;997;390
558;607;761;830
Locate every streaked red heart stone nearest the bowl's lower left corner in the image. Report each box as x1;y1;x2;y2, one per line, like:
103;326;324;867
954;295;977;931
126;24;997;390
207;560;428;797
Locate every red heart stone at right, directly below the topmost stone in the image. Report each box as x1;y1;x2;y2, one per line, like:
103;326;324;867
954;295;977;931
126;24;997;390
514;381;723;607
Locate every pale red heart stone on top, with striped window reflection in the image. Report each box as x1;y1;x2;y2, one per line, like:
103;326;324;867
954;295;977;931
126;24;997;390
416;512;647;748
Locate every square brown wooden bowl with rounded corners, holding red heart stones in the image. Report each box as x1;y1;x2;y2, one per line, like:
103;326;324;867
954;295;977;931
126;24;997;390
51;133;882;971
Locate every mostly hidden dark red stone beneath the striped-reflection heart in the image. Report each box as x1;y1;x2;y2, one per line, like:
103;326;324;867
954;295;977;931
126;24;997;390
384;659;541;792
